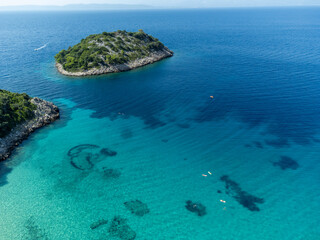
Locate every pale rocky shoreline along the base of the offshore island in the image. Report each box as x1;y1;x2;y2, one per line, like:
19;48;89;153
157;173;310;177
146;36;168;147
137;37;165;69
56;47;173;77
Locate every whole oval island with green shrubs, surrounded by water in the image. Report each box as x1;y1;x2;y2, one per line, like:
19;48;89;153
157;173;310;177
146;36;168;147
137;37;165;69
55;30;173;76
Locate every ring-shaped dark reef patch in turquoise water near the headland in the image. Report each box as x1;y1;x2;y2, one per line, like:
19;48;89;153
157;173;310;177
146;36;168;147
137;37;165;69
68;144;117;170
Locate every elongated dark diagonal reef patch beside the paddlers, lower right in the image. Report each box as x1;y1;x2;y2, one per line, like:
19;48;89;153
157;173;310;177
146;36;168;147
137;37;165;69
220;175;264;211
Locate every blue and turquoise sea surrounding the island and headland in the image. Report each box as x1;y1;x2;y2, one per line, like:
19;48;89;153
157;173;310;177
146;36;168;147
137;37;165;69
0;8;320;240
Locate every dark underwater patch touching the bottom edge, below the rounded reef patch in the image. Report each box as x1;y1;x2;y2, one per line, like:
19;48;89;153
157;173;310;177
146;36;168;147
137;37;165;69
108;216;136;240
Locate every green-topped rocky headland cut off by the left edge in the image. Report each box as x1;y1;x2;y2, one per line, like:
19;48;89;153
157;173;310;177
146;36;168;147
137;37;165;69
0;89;60;161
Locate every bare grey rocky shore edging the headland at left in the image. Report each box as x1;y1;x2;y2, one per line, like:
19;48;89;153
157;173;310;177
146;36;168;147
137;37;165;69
0;97;60;161
